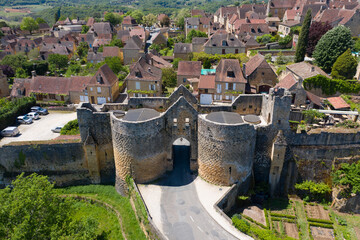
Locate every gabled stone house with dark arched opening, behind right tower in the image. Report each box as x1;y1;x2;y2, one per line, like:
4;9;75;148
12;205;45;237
243;54;277;93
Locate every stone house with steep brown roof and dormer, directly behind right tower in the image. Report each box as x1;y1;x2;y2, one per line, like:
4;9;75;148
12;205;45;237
214;59;247;101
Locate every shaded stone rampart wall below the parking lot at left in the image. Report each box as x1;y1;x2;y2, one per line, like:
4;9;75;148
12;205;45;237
0;143;92;187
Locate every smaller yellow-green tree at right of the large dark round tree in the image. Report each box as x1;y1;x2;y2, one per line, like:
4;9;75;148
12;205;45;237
331;49;357;80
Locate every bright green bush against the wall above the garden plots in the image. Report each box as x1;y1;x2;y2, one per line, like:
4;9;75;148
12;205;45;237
295;181;331;201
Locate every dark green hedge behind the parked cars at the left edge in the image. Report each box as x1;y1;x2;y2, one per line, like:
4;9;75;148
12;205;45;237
0;97;36;130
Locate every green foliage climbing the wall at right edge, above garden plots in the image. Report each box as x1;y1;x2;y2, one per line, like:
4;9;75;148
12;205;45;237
332;161;360;194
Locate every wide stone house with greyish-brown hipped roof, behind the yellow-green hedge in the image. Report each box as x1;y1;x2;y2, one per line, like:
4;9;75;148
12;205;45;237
204;30;245;54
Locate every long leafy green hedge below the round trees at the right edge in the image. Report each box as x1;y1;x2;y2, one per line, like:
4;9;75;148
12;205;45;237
303;74;360;95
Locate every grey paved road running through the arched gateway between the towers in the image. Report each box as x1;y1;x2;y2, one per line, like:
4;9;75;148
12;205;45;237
157;146;236;240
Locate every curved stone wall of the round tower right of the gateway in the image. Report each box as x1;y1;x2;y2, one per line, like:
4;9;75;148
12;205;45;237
198;115;256;185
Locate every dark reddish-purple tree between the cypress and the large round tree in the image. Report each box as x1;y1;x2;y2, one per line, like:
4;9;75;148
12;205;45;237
306;22;332;57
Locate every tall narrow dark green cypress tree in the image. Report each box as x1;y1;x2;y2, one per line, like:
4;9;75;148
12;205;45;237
295;9;311;62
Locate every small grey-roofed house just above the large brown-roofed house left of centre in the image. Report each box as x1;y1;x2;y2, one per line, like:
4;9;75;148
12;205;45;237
122;36;144;65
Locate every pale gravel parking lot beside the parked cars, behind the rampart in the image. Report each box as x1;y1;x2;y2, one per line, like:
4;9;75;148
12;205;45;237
0;111;76;146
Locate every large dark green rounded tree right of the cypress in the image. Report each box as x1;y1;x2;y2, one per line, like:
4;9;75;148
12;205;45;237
313;25;354;72
